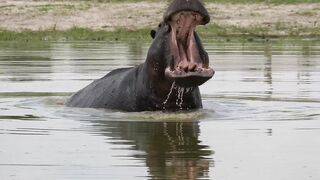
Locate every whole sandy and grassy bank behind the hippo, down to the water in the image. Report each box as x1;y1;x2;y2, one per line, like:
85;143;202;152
0;0;320;42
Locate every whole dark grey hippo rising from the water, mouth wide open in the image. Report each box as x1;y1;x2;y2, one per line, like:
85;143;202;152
66;0;214;112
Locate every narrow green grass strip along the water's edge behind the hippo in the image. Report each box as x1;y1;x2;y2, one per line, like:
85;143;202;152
0;23;320;42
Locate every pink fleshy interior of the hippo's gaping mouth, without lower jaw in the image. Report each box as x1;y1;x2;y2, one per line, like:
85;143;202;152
170;11;202;72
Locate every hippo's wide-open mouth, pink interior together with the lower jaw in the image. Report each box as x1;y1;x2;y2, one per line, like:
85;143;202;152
165;11;214;87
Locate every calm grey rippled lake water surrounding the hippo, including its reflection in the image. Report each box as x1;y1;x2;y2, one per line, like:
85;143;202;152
0;39;320;180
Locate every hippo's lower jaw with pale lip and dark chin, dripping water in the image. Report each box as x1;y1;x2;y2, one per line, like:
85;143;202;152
165;68;215;87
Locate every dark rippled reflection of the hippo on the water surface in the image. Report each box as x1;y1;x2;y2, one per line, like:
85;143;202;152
94;121;213;179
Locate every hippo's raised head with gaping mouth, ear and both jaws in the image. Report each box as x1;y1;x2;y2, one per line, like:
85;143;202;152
148;0;214;87
